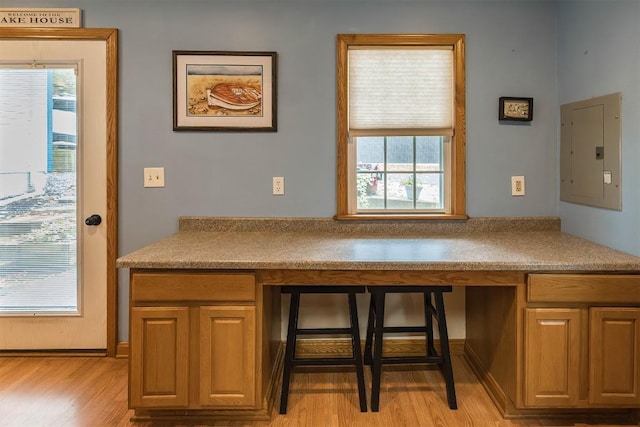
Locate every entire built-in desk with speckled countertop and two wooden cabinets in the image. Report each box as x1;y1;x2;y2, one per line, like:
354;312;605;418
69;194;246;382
118;217;640;419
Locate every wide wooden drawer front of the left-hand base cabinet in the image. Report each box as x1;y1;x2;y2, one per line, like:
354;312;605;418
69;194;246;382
131;272;256;302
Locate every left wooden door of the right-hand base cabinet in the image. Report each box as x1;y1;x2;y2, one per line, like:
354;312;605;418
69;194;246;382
524;308;581;407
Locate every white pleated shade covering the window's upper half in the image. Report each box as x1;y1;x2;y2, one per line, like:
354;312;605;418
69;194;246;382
349;48;454;131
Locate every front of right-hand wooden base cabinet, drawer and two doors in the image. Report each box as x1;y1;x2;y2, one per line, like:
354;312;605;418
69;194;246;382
523;274;640;408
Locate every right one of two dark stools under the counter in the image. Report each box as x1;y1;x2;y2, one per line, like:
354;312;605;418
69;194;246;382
364;286;458;412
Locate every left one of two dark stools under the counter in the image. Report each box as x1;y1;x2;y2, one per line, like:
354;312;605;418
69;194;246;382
280;286;367;414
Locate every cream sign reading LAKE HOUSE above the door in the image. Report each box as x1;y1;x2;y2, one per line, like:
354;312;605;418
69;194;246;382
0;8;82;28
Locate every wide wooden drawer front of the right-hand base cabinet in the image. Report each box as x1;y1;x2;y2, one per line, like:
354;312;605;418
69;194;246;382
527;274;640;305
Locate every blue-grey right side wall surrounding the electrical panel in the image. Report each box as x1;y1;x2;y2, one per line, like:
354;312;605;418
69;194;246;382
558;0;640;255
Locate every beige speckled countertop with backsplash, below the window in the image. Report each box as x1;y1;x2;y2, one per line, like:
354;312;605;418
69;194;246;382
117;217;640;272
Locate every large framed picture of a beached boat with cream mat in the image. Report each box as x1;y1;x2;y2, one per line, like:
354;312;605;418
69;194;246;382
173;51;277;132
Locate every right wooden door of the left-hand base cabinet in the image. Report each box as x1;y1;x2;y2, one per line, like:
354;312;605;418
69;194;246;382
200;306;257;408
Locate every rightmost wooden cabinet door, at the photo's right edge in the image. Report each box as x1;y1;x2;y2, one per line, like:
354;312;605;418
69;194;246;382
589;307;640;406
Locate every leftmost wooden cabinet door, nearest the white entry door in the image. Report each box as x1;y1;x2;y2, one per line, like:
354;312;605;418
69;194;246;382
129;307;189;408
